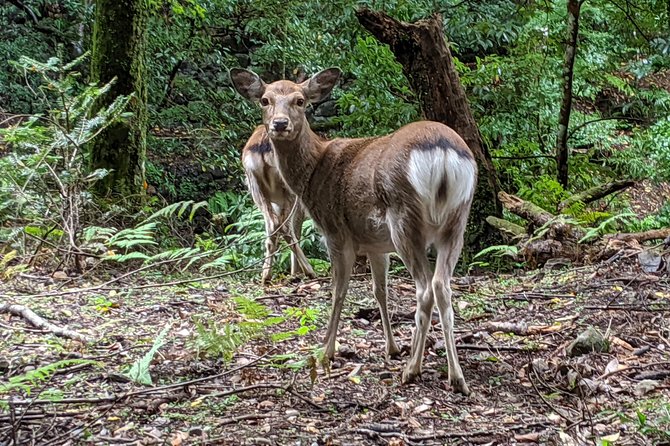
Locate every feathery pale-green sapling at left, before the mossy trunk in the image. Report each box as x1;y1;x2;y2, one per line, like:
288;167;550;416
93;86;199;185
0;56;131;266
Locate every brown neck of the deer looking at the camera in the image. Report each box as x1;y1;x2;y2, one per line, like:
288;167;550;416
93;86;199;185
272;122;325;197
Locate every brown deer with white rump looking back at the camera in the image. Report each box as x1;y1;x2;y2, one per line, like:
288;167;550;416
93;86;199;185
234;68;477;395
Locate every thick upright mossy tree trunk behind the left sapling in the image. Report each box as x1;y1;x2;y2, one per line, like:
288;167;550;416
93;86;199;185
91;0;148;196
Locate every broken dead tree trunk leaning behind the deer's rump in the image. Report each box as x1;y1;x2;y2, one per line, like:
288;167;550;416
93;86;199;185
356;9;502;254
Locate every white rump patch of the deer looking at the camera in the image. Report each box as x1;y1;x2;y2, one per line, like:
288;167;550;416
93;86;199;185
407;147;475;225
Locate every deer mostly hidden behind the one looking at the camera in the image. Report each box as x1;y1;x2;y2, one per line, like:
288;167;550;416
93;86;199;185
242;125;316;285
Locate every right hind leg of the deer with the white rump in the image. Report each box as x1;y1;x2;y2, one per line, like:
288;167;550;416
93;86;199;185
431;232;470;395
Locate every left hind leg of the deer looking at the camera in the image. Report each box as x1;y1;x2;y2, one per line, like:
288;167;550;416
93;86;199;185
389;223;434;383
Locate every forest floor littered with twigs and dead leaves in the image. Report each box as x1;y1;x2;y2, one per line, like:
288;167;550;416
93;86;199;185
0;255;670;446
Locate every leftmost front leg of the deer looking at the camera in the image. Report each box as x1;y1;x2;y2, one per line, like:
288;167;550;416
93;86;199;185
324;243;356;359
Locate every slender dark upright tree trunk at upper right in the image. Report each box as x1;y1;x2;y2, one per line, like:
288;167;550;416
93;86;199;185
556;0;583;189
